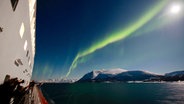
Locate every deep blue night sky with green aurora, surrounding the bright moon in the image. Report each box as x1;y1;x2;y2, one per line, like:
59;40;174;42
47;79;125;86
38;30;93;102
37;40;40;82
32;0;184;80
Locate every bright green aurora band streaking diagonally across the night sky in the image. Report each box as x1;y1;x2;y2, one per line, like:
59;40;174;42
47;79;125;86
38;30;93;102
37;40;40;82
66;0;166;77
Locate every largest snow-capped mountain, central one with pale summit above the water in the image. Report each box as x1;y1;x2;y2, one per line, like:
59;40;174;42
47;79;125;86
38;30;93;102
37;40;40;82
79;69;161;82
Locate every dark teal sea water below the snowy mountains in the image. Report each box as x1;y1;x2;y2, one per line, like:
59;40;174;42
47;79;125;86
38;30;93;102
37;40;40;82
42;83;184;104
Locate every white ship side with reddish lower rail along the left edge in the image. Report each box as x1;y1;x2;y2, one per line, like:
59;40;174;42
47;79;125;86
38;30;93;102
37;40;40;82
0;0;47;104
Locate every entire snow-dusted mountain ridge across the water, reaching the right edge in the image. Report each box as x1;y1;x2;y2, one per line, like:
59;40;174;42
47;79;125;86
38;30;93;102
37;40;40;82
77;68;184;82
